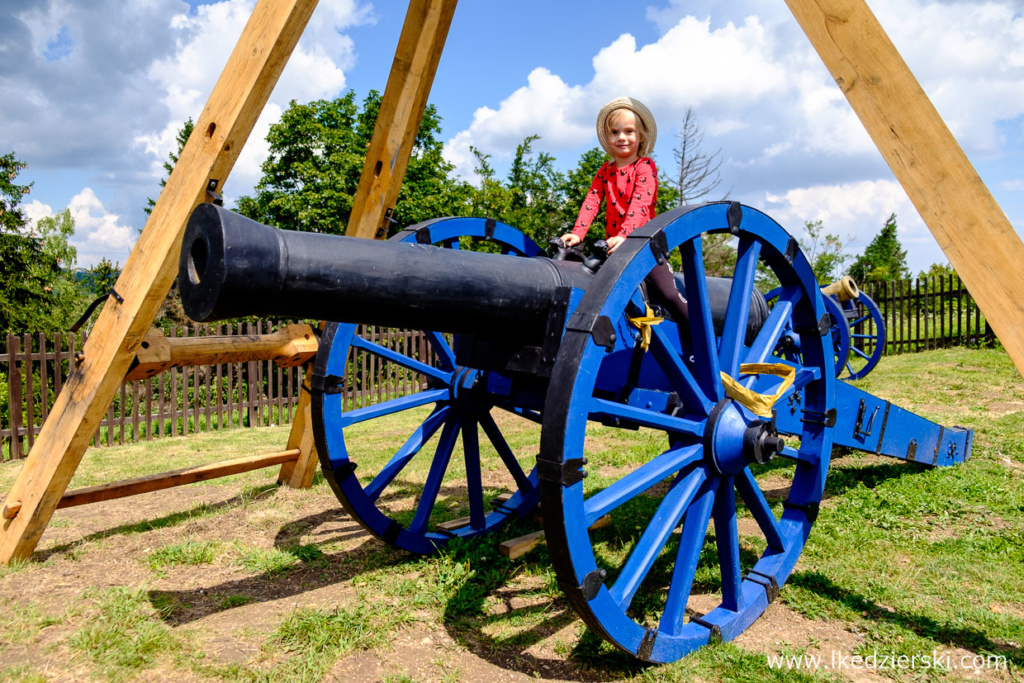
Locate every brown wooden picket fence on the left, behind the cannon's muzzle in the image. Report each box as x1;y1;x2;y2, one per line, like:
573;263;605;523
0;322;433;461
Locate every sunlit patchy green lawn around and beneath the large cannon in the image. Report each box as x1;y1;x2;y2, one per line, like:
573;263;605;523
0;349;1024;681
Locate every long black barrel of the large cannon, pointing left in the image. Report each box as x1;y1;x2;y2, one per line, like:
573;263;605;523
178;204;592;343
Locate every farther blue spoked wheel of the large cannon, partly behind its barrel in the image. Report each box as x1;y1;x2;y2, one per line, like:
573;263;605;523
311;218;541;554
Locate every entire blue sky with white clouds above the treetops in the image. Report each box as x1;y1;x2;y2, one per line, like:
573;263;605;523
6;0;1024;273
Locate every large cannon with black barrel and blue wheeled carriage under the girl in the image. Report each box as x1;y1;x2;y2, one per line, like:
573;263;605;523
179;202;972;663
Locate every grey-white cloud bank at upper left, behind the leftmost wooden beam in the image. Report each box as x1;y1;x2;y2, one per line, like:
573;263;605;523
0;0;374;264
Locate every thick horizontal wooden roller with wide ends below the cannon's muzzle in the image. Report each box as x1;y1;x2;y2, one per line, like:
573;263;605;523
125;324;317;380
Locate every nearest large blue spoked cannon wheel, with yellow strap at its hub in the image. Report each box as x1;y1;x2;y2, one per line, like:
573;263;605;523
539;203;836;663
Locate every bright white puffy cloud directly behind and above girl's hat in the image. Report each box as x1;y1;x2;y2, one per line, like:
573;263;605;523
445;16;786;176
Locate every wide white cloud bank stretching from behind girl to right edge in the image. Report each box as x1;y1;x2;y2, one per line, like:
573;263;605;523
445;0;1024;269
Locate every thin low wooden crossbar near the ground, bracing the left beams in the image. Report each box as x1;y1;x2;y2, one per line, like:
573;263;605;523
2;449;299;519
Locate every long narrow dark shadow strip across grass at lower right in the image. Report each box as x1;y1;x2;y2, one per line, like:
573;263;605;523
787;571;1024;667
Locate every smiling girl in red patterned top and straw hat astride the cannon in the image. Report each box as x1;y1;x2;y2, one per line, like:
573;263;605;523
561;97;688;329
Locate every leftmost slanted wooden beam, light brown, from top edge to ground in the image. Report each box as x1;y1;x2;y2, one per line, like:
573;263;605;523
0;0;316;562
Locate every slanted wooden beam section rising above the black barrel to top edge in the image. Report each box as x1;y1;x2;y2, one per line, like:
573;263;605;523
345;0;457;239
